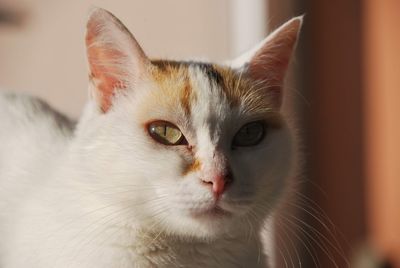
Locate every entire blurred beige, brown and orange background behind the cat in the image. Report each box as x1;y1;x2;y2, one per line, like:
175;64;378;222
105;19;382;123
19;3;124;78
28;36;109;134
0;0;400;268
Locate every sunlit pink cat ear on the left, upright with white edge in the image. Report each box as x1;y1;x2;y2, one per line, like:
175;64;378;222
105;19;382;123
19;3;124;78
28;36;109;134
86;8;150;112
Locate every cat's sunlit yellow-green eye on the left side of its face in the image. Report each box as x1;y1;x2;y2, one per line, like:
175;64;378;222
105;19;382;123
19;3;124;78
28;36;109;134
148;121;187;145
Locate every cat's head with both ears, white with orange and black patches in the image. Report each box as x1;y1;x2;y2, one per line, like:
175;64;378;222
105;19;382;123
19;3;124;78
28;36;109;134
77;9;301;238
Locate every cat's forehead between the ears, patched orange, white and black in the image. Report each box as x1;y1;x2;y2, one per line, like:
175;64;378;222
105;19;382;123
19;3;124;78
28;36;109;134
151;60;271;121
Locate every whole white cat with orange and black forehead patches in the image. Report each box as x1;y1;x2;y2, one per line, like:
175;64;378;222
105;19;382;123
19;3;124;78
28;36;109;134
0;8;302;268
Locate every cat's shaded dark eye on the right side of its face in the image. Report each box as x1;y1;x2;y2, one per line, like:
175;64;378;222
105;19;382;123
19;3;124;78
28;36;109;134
232;121;265;147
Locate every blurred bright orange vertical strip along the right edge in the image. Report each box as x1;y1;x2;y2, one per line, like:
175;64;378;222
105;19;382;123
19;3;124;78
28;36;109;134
363;0;400;267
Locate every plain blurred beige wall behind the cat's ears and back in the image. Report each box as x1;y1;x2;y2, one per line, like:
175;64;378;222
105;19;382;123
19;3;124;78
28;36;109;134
0;0;265;116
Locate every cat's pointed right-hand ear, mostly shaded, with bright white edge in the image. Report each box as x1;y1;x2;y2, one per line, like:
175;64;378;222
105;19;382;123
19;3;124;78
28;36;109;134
230;16;303;108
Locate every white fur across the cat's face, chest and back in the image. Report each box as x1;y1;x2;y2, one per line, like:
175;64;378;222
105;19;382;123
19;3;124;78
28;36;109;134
0;7;300;268
